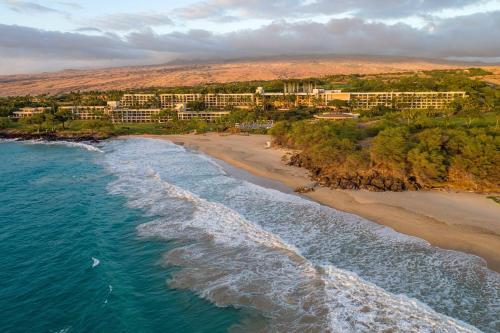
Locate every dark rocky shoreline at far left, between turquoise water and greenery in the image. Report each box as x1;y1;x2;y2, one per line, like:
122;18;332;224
0;131;110;143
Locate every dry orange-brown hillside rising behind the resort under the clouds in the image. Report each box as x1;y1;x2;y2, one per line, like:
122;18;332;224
0;57;496;96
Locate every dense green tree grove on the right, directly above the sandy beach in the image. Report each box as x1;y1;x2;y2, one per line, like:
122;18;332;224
272;114;500;191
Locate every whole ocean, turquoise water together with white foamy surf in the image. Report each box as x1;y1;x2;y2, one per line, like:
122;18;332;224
0;139;500;332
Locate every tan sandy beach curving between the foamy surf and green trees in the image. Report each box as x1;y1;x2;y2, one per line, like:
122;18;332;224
128;133;500;272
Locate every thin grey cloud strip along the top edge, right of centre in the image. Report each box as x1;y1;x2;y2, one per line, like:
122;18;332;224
177;0;484;21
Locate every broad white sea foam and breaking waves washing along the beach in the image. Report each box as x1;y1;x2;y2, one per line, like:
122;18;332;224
99;140;500;332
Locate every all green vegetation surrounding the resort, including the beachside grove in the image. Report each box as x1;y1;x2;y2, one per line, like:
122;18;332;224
0;69;500;191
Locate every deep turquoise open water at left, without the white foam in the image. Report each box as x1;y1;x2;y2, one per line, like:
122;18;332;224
0;143;240;332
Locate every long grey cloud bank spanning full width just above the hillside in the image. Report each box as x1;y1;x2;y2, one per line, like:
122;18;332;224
0;11;500;73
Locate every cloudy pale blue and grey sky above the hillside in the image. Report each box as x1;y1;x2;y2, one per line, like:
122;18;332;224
0;0;500;75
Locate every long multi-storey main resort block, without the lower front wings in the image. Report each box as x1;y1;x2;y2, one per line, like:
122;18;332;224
119;87;466;110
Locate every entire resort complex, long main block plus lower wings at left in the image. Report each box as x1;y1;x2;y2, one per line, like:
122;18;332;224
13;80;466;123
